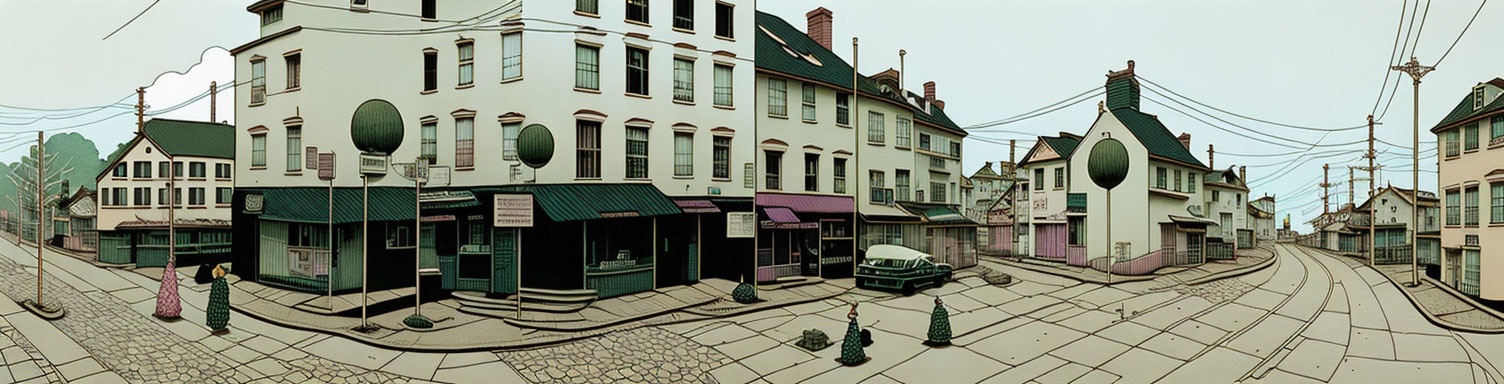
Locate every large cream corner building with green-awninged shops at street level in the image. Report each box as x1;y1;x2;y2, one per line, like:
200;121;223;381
232;0;758;297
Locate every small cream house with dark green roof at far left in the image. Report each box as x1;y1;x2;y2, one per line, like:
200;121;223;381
95;119;236;267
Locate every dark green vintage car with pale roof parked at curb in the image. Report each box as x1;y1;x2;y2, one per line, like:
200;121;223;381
856;244;951;295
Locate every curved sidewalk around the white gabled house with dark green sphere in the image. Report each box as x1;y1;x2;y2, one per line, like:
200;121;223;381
987;242;1274;285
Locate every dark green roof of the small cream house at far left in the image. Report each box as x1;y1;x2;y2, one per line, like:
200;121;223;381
144;119;235;158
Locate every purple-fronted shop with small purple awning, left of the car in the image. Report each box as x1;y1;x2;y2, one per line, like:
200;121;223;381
757;193;856;282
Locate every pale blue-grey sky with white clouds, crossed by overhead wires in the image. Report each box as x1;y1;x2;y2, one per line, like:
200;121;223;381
0;0;1504;232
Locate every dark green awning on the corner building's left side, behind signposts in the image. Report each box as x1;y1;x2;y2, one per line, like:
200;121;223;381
253;187;417;223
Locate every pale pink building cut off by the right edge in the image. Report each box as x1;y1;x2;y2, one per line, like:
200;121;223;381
1430;78;1504;301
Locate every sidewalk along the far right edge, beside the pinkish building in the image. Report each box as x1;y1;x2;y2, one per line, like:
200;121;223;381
1307;247;1504;333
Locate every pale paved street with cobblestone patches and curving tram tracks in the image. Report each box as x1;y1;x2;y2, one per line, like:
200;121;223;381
0;242;1504;382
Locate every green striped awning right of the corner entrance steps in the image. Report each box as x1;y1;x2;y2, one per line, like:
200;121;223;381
499;184;681;221
